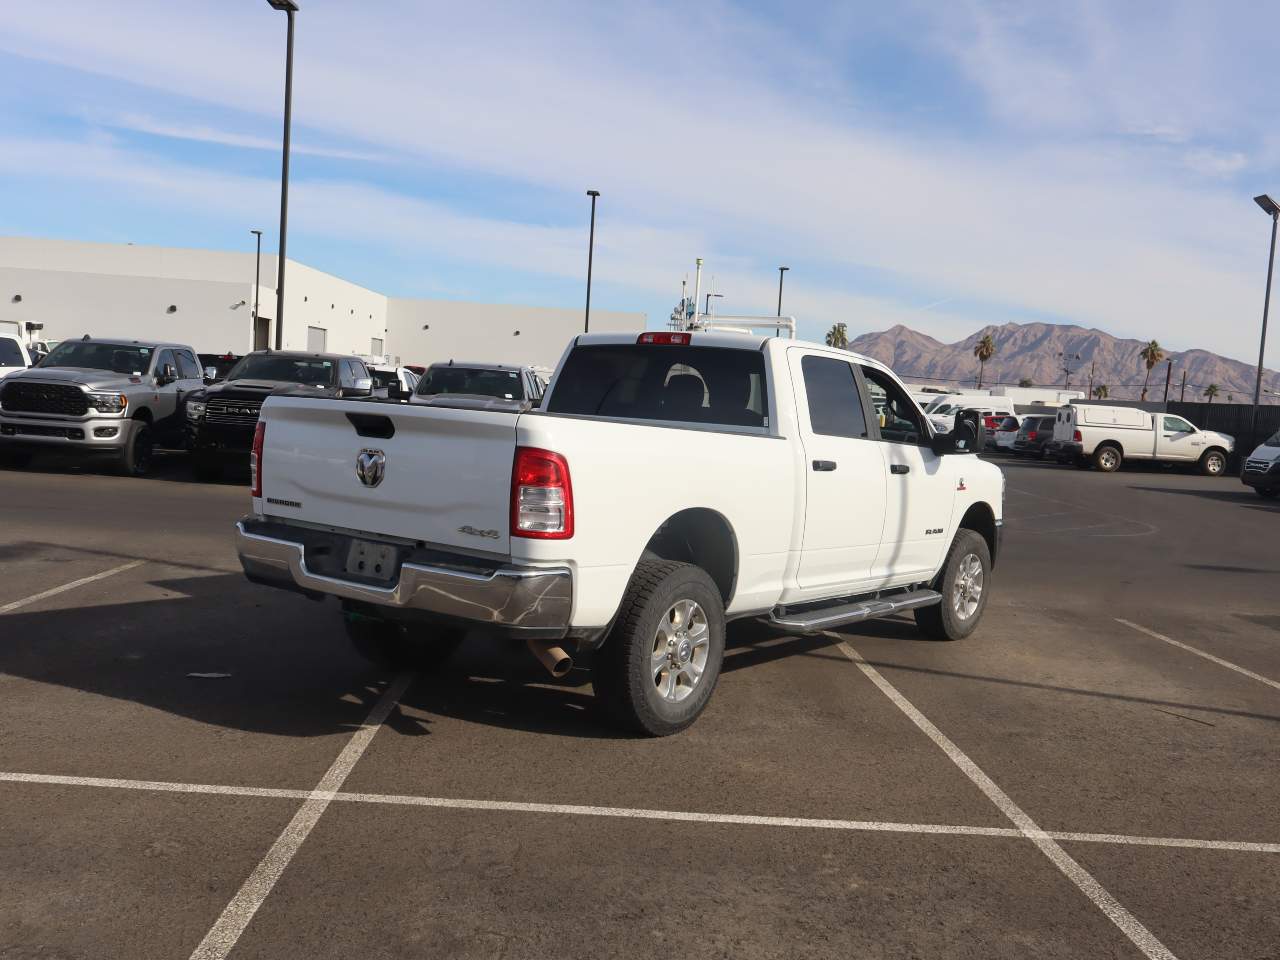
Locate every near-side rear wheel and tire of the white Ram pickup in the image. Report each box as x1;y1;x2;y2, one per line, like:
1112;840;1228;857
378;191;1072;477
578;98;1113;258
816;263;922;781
591;559;724;737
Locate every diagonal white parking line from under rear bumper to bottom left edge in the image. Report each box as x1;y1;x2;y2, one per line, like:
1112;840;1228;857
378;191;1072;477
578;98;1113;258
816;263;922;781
191;673;413;960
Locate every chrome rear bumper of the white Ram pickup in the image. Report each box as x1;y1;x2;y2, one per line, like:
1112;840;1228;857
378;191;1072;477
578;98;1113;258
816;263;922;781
236;521;573;630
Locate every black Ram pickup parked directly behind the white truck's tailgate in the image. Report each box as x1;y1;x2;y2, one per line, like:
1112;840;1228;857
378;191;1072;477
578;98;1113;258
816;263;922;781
187;349;374;480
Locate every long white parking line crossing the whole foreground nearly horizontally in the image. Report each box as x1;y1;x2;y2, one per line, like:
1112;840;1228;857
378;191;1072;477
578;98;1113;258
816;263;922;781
0;772;1280;854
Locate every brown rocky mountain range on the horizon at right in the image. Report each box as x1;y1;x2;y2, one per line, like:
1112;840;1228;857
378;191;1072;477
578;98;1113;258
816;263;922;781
849;324;1280;403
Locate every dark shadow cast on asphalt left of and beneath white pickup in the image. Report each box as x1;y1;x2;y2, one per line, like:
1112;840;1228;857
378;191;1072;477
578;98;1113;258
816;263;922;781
0;567;640;739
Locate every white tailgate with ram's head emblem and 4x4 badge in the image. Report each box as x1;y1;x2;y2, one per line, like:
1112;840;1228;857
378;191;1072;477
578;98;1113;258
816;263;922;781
261;397;518;556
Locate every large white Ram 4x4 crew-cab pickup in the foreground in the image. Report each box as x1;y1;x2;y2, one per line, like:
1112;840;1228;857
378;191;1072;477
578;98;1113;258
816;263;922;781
238;332;1004;736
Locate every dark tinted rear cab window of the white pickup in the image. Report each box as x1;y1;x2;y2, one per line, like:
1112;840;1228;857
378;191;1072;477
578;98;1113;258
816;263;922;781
544;343;769;429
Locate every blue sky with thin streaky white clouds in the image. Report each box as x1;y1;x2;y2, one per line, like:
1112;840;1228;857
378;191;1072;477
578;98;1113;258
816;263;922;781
0;0;1280;367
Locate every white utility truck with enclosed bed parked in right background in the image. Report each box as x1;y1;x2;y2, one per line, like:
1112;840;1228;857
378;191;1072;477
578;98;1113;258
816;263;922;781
1052;403;1235;476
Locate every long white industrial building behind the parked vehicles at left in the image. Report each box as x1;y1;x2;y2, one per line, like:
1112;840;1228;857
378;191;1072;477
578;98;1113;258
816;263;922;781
0;237;645;367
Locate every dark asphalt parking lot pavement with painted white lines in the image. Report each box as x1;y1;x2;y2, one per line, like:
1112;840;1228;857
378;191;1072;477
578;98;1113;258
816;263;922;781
0;458;1280;960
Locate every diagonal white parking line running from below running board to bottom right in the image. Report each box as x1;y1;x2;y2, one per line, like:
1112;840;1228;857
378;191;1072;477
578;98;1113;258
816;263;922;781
828;634;1176;960
